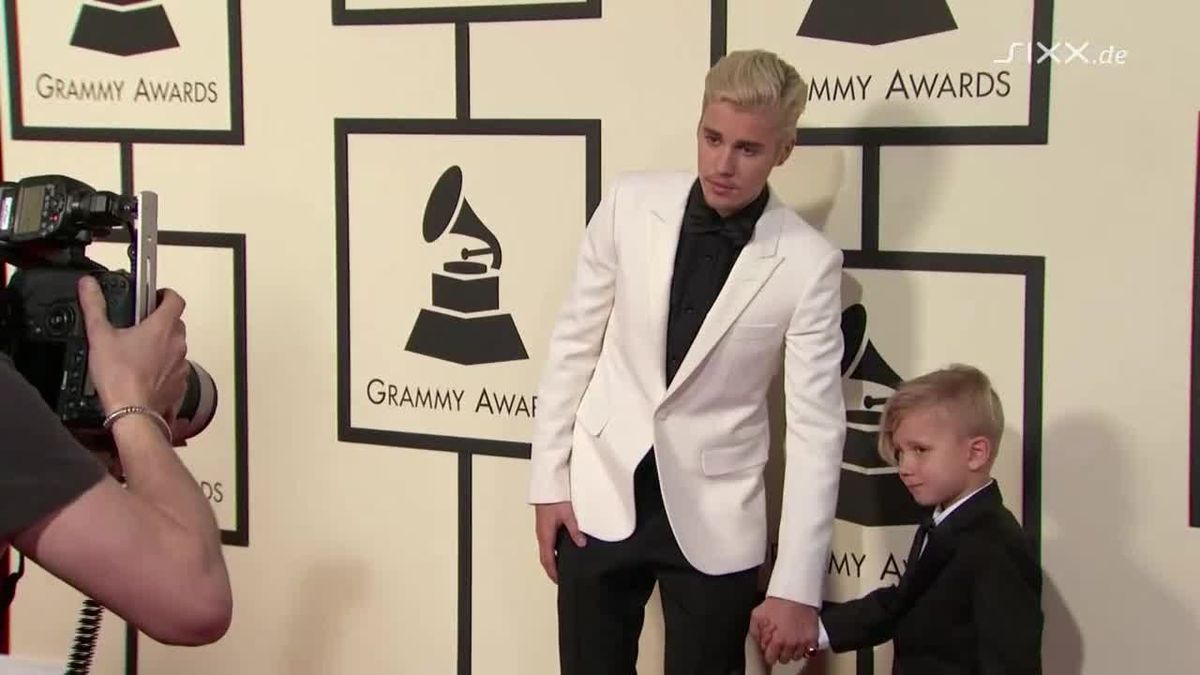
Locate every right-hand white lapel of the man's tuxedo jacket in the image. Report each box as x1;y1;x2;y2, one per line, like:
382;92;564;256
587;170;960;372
662;193;785;398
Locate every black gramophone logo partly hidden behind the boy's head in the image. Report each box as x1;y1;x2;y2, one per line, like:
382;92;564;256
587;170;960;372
838;304;924;527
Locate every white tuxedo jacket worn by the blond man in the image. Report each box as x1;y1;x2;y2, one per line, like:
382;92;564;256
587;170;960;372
529;173;845;607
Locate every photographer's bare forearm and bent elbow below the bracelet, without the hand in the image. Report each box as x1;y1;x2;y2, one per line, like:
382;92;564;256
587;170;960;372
13;416;233;645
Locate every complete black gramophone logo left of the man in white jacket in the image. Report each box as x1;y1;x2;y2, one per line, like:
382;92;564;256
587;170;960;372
404;166;529;365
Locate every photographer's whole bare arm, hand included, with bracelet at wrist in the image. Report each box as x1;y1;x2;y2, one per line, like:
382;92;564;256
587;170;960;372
14;279;233;645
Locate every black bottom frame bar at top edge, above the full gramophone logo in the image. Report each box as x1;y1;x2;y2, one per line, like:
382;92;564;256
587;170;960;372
332;0;601;25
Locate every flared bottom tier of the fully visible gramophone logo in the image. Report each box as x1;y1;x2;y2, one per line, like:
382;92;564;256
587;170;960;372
404;310;529;365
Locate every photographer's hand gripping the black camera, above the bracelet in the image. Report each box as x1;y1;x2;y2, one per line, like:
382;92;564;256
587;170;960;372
79;276;187;422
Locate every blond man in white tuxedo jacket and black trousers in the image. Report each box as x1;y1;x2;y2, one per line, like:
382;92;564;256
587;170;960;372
528;50;845;675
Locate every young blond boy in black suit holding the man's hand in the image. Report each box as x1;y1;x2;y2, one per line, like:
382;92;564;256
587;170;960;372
801;365;1043;675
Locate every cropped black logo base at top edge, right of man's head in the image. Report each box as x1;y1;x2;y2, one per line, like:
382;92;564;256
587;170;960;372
796;0;959;46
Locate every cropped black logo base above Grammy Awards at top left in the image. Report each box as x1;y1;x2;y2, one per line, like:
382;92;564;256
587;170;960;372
71;0;179;56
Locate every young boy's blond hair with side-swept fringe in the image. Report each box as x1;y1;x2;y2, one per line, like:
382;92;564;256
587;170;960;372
880;364;1004;464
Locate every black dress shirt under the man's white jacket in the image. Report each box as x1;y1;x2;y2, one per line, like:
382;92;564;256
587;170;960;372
666;179;769;386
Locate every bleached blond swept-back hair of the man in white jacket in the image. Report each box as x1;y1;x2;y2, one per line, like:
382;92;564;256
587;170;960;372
701;49;809;133
